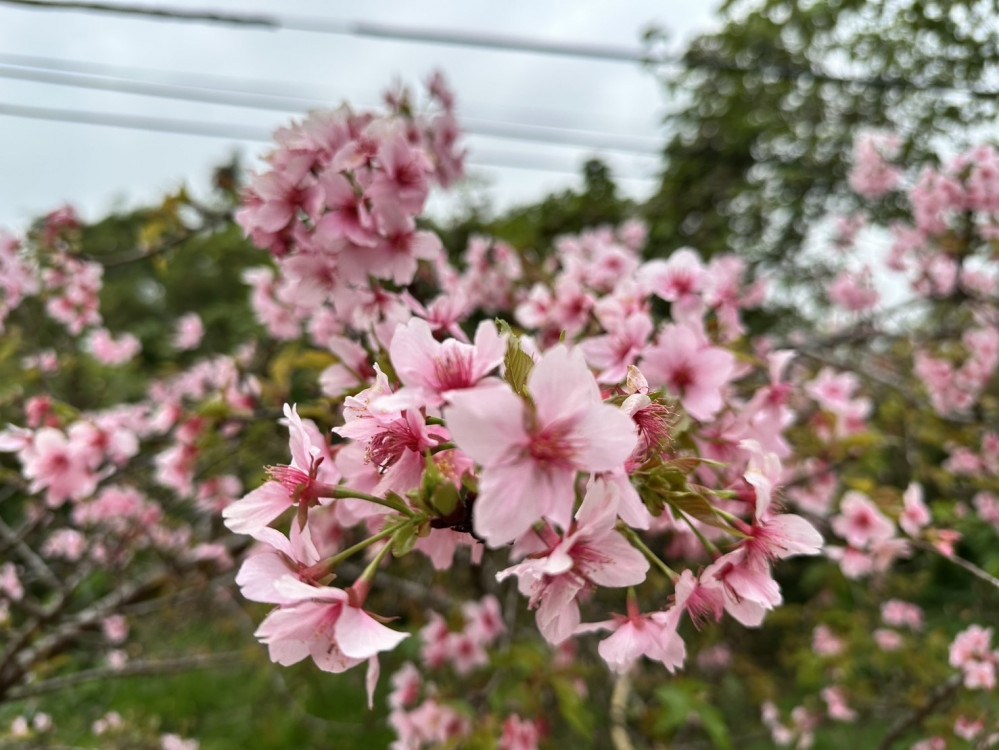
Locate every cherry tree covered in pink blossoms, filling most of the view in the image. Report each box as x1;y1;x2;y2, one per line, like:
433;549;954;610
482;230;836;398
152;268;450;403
0;70;999;748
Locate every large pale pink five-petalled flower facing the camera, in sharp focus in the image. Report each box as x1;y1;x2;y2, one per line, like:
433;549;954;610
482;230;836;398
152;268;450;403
444;346;637;547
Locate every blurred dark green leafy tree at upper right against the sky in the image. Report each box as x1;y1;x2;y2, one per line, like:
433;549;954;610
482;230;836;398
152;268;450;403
643;0;997;270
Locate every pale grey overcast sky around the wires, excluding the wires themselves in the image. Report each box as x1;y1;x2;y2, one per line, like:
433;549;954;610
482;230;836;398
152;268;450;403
0;0;717;229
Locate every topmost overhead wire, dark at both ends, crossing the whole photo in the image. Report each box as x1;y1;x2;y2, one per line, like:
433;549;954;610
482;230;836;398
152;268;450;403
0;0;999;99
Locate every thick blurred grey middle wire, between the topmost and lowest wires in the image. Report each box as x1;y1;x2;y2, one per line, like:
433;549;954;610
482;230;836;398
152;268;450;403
0;54;660;157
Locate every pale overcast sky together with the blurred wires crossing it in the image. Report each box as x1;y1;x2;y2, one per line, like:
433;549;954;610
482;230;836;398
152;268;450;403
0;0;718;227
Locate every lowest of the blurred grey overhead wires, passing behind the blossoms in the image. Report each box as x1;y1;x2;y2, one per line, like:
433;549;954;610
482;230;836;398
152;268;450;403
0;103;656;181
